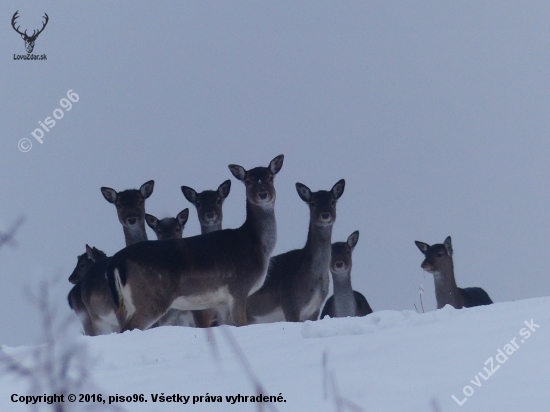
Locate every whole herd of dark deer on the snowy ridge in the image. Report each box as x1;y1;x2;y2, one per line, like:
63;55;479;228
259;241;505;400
68;155;492;336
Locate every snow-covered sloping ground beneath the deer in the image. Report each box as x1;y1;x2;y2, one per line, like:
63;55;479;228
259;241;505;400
0;297;550;412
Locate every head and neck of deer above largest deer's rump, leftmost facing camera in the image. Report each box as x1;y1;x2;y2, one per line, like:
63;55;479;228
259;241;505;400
101;180;155;246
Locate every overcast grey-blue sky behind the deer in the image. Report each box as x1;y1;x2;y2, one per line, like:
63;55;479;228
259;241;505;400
0;0;550;345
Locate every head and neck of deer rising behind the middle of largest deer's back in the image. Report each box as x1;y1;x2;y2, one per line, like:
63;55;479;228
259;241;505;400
181;180;231;234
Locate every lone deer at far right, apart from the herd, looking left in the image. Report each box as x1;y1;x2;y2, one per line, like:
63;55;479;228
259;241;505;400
414;236;493;309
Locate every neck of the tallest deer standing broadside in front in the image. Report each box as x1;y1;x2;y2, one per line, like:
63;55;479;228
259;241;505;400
241;200;277;258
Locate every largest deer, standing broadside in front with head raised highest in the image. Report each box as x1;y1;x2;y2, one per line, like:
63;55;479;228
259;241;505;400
107;155;284;332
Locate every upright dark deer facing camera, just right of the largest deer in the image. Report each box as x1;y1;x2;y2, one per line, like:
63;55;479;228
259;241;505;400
247;179;346;323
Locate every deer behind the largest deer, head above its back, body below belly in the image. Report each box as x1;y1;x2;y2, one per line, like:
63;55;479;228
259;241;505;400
181;179;231;328
